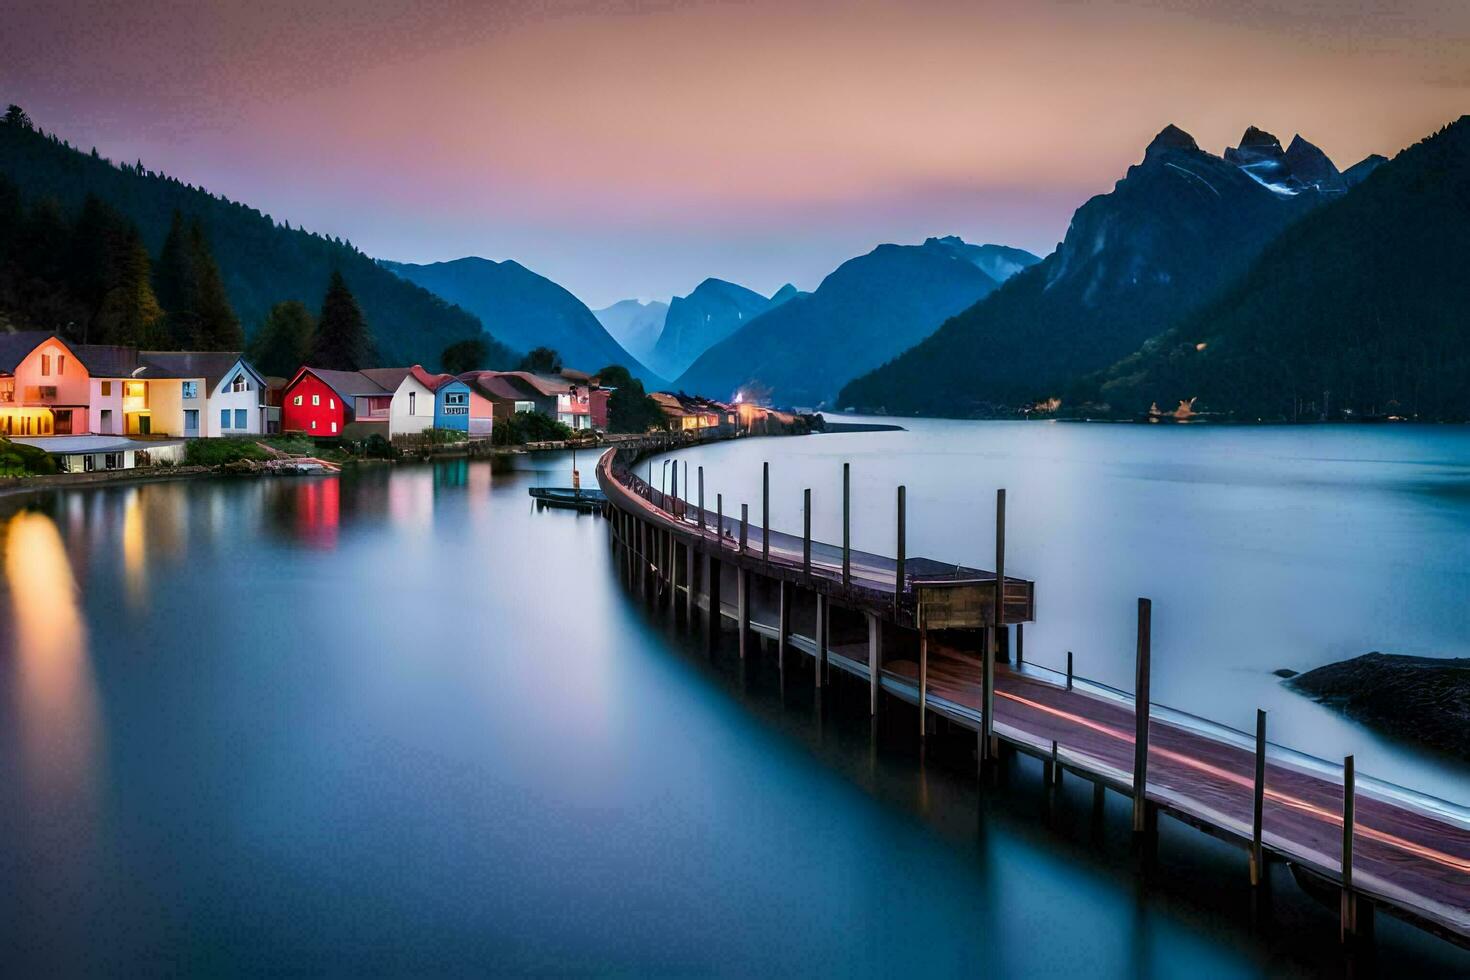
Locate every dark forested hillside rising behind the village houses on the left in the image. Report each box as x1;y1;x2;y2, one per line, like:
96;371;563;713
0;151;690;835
0;112;510;367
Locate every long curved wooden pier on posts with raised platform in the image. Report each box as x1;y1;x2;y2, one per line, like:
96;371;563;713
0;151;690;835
597;450;1470;948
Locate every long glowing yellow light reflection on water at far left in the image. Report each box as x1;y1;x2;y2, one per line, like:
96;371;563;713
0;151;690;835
4;511;97;810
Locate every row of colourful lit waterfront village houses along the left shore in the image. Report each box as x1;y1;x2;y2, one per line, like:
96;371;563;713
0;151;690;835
0;331;797;476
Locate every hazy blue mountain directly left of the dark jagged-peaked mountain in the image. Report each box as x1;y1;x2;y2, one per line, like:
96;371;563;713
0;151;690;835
670;238;1038;406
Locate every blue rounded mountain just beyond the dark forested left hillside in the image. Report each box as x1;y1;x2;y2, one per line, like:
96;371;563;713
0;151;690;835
382;256;659;383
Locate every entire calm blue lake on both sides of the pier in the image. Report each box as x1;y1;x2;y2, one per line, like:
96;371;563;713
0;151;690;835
0;422;1470;976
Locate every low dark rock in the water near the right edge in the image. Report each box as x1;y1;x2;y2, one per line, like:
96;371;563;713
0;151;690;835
1288;652;1470;760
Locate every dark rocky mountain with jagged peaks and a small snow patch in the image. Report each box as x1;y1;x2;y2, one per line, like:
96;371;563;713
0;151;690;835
838;126;1344;416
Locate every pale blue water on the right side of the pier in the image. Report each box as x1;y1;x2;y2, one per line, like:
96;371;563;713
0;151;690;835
653;419;1470;805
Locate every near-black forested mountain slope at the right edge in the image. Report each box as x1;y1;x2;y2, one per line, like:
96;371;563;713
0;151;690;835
1091;116;1470;420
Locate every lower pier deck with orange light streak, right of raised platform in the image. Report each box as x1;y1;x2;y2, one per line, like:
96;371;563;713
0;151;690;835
995;661;1470;943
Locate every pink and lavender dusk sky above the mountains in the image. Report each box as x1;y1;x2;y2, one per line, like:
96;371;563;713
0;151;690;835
0;0;1470;307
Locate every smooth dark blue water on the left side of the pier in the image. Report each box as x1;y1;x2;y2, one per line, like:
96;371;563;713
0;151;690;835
0;458;1467;976
